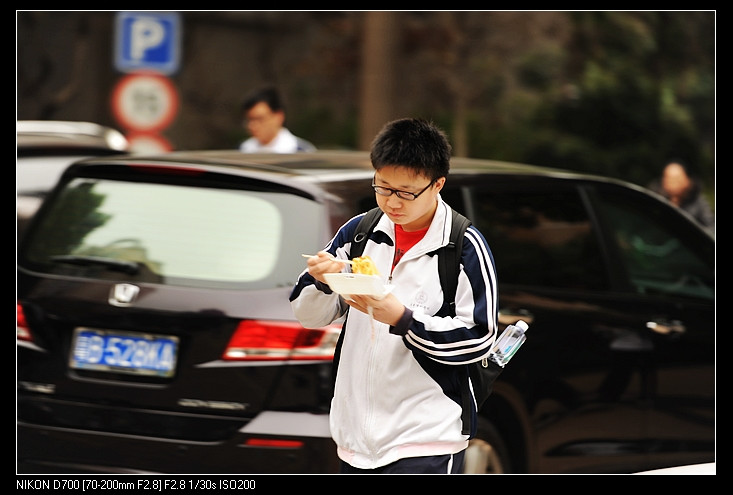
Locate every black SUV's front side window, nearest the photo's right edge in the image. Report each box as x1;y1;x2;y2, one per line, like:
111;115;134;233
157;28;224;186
598;190;715;300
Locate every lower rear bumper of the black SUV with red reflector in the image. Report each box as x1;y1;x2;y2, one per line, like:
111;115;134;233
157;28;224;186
17;412;338;474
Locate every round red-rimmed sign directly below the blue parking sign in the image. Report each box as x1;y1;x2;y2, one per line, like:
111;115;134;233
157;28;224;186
112;73;178;132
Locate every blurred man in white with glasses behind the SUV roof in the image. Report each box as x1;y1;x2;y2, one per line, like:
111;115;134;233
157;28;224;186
239;87;316;153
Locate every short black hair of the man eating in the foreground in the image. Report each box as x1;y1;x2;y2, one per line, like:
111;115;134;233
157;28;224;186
370;118;452;180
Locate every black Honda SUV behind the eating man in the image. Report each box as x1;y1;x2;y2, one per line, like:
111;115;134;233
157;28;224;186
17;151;715;474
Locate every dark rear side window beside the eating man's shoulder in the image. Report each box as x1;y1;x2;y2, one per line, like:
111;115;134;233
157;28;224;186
471;186;608;289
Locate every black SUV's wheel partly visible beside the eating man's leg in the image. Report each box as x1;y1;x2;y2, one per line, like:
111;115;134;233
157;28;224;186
463;419;511;474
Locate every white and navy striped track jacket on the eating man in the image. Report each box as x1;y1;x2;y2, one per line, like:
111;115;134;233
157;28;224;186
290;199;498;469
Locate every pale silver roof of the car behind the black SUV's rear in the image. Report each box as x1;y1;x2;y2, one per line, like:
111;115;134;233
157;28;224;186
16;120;129;154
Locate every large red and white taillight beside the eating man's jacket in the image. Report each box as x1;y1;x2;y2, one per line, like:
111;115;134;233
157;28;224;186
222;320;341;361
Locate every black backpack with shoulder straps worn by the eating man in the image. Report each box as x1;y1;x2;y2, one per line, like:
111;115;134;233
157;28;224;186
348;207;503;437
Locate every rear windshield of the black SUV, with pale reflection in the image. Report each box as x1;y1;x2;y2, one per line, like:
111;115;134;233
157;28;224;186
24;178;322;289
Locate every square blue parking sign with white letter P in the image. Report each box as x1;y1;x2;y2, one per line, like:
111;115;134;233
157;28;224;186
115;12;181;75
